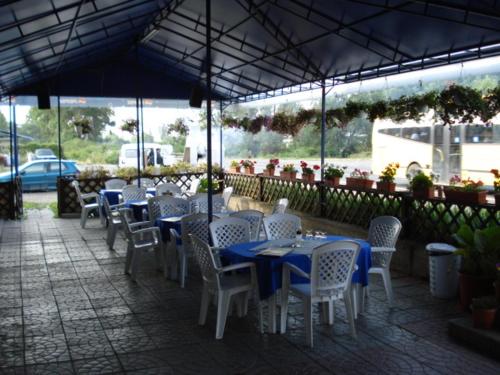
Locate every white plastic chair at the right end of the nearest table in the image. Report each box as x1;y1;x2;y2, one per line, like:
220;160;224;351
368;216;403;306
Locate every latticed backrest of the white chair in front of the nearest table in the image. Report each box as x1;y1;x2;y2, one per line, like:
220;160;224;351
311;241;360;297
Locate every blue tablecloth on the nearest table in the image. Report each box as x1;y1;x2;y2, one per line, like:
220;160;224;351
222;236;372;299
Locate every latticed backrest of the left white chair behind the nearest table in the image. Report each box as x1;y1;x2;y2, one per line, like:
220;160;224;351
209;217;250;248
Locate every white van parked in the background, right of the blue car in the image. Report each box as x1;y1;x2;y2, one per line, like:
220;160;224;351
118;143;175;167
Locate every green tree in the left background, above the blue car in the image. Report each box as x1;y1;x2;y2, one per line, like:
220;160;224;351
22;107;115;142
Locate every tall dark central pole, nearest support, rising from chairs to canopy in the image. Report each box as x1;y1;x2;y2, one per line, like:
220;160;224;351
205;0;213;222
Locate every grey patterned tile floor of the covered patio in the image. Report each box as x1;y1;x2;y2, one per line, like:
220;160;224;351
0;211;500;375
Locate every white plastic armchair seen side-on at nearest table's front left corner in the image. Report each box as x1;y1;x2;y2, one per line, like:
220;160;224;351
191;235;263;339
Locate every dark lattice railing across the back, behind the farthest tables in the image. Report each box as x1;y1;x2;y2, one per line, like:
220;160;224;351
57;172;223;216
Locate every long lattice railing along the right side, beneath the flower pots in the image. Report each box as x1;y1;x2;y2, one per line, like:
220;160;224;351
224;173;500;241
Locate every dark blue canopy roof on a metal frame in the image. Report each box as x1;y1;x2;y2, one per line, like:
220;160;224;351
0;0;500;101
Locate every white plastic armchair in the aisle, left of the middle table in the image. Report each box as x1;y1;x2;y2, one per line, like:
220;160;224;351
119;208;163;281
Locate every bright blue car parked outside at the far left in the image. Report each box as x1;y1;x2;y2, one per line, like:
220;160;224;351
0;160;80;191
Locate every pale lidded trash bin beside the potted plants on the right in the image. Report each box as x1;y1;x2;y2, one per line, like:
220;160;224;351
425;242;460;299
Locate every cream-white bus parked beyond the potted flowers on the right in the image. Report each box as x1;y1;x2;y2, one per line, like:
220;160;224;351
372;115;500;185
